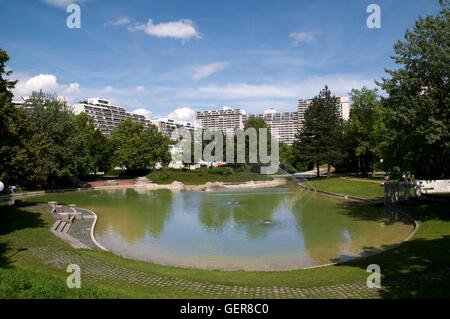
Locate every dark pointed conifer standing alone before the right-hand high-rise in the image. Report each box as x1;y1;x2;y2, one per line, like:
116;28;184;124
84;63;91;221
294;86;343;176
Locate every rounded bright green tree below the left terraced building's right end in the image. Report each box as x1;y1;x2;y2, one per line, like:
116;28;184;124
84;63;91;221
111;119;171;174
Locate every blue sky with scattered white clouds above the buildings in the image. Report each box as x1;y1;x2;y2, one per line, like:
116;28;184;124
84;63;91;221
0;0;439;120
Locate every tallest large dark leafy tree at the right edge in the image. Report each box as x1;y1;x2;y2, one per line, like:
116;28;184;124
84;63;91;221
378;1;450;179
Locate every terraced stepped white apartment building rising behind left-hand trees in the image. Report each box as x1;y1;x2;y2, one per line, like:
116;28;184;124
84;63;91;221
71;98;152;135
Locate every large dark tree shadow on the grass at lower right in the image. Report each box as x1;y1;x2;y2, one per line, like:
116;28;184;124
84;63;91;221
336;199;450;298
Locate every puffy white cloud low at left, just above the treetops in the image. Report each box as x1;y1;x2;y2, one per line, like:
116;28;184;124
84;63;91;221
14;74;80;96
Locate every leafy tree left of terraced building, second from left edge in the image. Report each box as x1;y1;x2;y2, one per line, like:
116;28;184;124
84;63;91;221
27;92;93;187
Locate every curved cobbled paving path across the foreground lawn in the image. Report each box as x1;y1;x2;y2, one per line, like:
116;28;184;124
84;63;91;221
24;246;450;299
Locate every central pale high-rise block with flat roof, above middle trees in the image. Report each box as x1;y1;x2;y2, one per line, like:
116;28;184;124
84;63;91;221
196;107;247;135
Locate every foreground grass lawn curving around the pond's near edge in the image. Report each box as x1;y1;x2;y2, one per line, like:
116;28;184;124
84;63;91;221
0;180;450;298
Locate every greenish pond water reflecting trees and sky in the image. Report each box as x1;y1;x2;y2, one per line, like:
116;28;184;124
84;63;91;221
22;186;413;270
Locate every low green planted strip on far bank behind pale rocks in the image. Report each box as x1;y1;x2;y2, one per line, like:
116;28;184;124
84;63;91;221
147;168;273;185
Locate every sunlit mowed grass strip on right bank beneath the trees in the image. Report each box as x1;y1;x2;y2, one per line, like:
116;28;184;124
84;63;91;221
305;177;384;200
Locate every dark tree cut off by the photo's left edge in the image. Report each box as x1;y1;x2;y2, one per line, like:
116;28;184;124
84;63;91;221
0;49;48;188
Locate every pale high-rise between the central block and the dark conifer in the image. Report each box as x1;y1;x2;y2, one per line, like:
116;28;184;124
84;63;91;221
255;109;298;145
